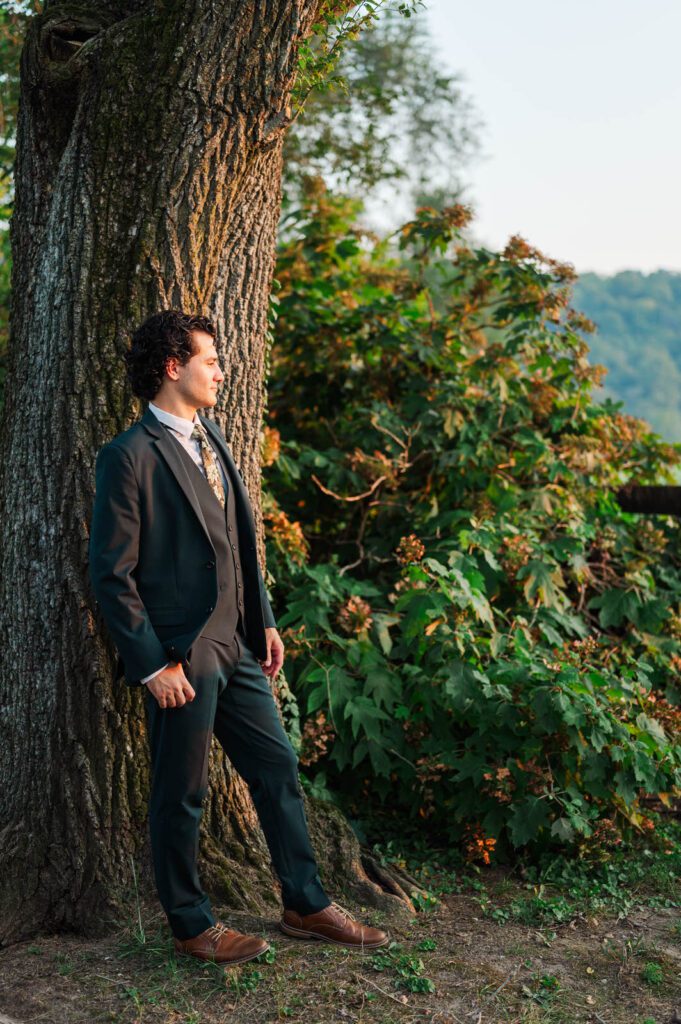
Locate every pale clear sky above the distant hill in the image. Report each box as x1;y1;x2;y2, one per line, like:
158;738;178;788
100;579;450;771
418;0;681;273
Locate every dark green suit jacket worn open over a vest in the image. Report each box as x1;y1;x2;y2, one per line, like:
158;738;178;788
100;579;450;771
89;409;276;685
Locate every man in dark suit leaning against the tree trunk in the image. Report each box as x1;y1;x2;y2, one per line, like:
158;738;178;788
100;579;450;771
90;309;388;964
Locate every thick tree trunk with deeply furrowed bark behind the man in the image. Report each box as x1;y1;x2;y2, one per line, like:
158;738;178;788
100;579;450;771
0;0;405;942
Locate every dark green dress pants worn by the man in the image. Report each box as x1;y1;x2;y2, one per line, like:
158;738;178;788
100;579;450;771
146;632;331;939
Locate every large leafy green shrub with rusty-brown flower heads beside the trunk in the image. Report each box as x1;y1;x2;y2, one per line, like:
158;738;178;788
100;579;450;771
263;180;681;861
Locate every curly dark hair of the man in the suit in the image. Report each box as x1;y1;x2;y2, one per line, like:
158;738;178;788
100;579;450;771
123;309;215;400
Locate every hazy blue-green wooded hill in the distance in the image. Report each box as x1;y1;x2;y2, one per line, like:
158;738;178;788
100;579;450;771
574;270;681;441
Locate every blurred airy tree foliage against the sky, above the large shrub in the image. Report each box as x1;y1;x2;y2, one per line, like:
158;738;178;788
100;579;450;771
284;0;479;211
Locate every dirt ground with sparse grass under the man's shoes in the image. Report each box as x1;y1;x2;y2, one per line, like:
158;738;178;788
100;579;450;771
0;872;681;1024
